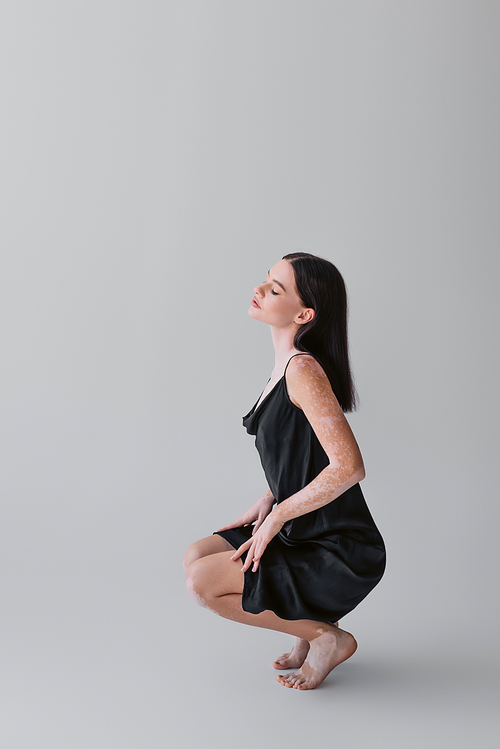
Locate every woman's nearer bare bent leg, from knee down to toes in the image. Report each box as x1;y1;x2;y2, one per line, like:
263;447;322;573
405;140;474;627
187;550;357;689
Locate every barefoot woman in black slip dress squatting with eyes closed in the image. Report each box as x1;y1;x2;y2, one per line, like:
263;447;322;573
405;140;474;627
184;252;385;689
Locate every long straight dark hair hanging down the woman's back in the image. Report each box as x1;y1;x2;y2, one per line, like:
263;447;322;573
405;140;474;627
283;252;358;412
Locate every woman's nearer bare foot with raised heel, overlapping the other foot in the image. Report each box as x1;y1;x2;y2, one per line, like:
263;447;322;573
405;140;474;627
276;627;358;689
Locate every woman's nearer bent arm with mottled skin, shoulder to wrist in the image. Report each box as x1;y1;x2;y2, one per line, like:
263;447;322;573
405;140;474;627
272;356;365;523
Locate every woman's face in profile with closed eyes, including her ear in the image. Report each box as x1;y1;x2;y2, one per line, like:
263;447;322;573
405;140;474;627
248;260;314;328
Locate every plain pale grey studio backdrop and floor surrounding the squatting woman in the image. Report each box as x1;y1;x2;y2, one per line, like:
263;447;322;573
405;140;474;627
0;0;500;749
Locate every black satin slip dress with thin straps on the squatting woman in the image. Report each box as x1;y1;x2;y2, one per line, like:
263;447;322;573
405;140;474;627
213;354;385;622
